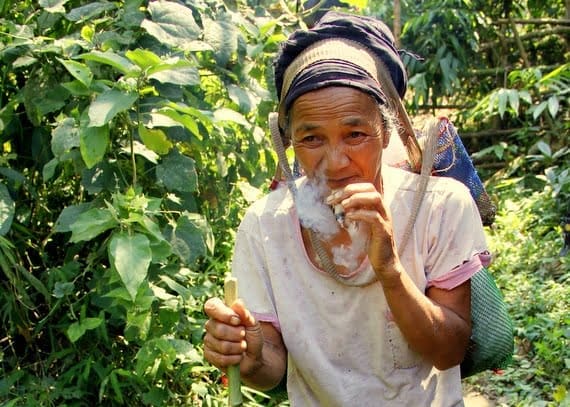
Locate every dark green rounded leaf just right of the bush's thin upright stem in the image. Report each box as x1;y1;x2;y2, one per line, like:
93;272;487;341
156;151;198;192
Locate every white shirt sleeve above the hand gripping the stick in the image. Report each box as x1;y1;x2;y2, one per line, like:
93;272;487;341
227;211;279;329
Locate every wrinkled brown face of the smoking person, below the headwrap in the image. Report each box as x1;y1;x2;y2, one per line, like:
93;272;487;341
289;86;387;190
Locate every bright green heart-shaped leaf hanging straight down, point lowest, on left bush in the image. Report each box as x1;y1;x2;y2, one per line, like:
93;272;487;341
109;232;152;301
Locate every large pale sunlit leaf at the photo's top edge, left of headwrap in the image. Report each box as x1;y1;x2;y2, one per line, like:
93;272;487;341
141;0;201;48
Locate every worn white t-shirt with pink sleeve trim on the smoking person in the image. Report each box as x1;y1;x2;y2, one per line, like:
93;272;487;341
232;167;487;407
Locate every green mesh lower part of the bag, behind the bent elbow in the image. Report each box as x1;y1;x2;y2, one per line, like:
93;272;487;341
461;268;514;378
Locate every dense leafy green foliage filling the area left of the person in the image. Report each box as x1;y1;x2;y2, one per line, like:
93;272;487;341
0;0;295;406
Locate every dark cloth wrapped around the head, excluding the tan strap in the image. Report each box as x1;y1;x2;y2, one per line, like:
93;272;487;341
274;12;407;112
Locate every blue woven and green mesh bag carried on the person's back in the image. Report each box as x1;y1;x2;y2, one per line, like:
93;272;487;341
410;118;514;377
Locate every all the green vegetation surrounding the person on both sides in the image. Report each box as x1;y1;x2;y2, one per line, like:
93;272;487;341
0;0;570;406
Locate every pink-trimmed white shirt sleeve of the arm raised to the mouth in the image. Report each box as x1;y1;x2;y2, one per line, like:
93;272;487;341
425;178;489;289
